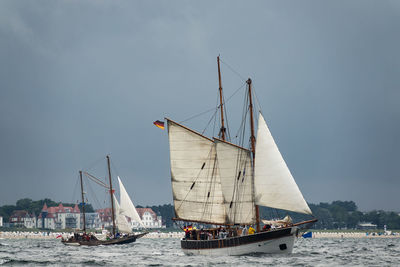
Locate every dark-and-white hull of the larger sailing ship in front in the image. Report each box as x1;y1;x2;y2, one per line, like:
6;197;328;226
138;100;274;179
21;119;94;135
181;227;297;256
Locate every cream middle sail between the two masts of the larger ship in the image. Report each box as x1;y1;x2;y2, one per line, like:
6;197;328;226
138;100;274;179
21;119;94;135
215;140;256;224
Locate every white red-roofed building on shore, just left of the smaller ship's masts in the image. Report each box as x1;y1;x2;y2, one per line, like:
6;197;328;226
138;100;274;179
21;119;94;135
37;203;81;229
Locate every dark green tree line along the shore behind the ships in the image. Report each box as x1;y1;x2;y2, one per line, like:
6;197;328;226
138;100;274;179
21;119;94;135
0;198;400;229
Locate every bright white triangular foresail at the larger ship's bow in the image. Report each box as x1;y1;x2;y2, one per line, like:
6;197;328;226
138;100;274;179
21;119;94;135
254;113;312;214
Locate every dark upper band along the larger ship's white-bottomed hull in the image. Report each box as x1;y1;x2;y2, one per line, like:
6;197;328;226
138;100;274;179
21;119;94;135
181;227;295;251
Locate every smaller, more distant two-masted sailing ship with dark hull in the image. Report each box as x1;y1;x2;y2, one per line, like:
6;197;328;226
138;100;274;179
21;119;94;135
61;155;148;246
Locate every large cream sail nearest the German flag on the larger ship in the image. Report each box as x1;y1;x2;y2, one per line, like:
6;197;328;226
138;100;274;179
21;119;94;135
168;120;226;224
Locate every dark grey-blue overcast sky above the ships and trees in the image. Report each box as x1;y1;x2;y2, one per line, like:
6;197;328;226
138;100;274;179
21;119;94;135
0;0;400;211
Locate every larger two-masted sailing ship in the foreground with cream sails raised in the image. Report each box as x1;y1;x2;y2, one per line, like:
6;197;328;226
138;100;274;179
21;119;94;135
165;56;317;255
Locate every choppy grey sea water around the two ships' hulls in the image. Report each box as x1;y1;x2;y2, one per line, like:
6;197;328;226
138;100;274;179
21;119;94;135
0;238;400;266
